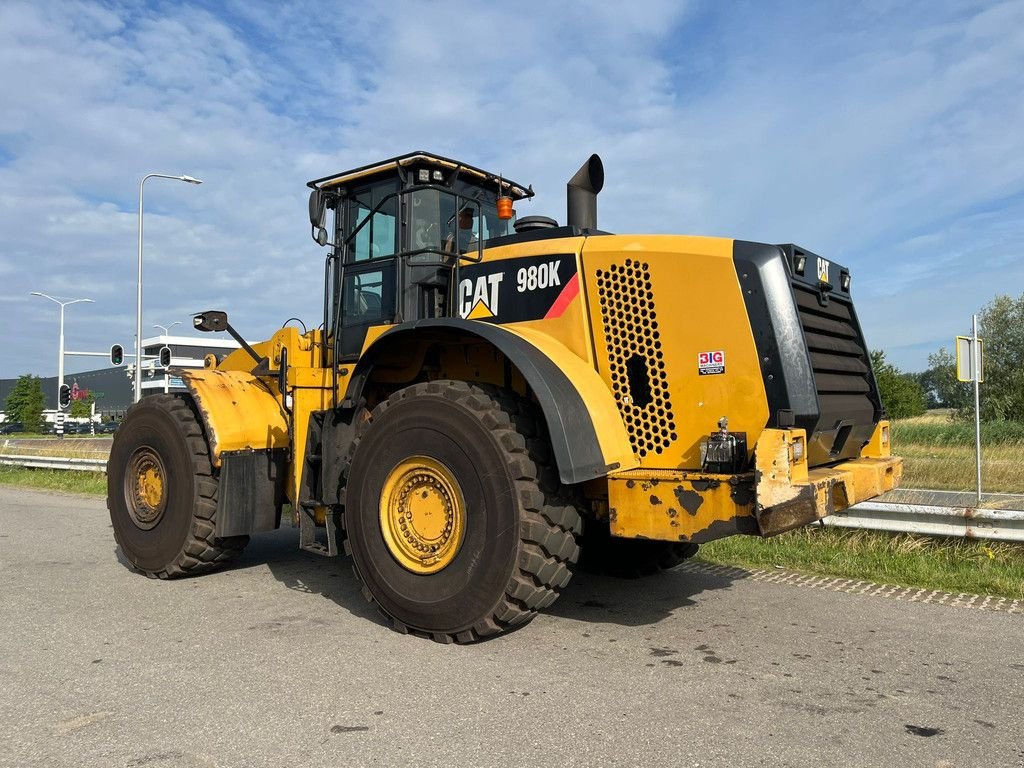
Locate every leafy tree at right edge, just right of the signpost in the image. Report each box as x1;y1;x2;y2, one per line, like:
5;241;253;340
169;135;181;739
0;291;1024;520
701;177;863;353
978;294;1024;421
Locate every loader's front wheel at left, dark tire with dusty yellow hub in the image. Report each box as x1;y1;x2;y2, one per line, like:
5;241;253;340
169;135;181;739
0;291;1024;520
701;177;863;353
106;394;249;579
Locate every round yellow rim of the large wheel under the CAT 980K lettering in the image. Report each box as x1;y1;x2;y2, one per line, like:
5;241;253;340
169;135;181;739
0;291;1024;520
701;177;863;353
380;456;466;573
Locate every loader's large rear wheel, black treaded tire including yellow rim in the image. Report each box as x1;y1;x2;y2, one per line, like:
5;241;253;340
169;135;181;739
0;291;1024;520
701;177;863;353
343;381;581;643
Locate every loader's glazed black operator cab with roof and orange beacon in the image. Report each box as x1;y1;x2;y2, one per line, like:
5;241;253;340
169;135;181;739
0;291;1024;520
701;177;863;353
308;152;534;361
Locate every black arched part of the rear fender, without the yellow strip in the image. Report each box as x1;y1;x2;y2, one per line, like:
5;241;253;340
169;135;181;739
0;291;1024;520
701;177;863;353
342;317;611;484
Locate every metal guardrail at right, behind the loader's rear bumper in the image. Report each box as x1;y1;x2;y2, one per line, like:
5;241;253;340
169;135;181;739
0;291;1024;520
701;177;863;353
821;502;1024;542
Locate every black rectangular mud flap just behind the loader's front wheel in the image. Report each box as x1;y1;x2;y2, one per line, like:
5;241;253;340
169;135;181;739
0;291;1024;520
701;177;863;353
217;449;288;537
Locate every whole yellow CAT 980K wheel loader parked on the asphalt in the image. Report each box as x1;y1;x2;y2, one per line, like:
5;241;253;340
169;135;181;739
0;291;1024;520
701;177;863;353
108;152;902;642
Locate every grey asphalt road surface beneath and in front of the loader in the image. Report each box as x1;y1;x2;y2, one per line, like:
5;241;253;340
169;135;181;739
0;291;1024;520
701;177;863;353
0;488;1024;768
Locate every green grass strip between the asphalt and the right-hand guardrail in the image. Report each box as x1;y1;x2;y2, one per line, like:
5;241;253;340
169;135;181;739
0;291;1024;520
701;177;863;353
698;526;1024;600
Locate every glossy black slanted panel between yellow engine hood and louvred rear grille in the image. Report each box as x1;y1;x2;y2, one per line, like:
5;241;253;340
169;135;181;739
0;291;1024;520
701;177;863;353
733;240;820;436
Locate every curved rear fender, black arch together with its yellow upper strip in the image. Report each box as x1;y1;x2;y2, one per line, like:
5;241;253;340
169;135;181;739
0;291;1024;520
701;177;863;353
342;317;637;484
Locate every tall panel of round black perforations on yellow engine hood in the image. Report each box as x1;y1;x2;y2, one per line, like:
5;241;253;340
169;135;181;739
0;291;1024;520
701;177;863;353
597;259;676;459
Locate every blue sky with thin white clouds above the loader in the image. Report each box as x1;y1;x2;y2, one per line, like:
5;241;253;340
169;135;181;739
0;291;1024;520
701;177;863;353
0;0;1024;377
